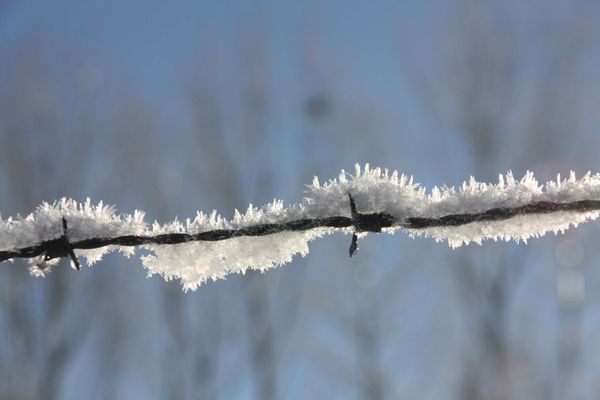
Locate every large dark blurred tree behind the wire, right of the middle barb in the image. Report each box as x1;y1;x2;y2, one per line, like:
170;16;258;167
441;0;520;400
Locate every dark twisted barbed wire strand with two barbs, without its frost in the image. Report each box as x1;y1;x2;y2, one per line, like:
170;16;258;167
0;198;600;269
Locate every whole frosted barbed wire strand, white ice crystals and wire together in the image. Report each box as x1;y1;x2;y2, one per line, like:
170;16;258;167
0;164;600;290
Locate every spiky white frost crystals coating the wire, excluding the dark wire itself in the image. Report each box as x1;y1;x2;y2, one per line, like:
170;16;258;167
0;165;600;290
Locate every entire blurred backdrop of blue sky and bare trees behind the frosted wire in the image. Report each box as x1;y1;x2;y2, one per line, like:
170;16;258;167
0;0;600;400
